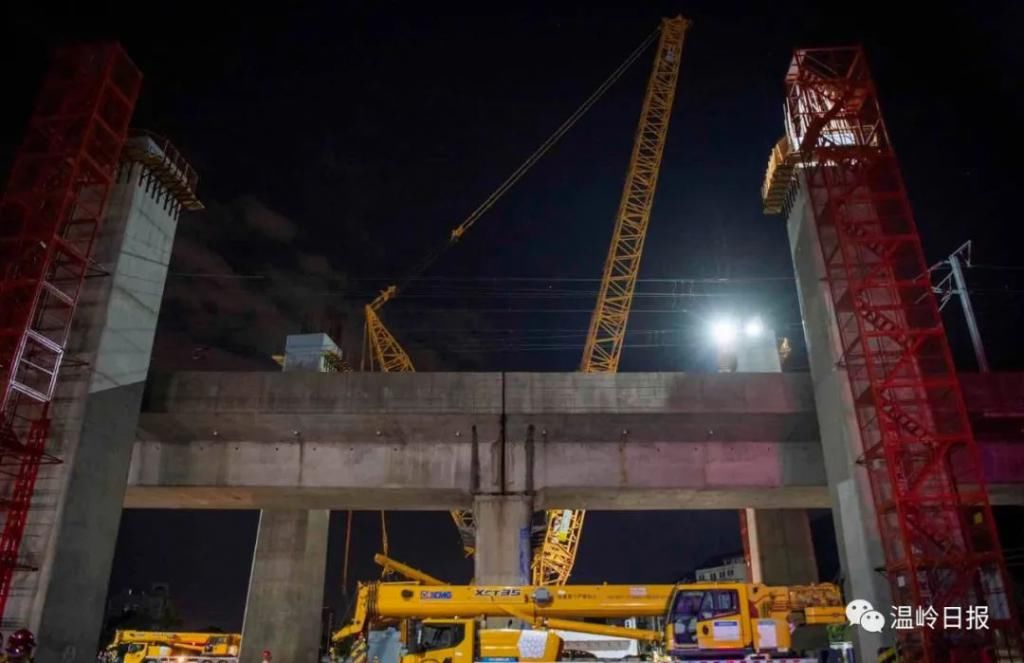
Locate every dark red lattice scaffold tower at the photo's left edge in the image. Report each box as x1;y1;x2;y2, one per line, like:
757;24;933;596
0;44;141;616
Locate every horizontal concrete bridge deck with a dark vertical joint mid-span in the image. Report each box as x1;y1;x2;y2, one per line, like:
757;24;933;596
125;372;1024;509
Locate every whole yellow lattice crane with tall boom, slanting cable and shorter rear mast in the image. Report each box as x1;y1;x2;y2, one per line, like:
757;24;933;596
362;16;690;585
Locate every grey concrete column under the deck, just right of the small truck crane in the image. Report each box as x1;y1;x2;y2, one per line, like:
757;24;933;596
240;509;331;663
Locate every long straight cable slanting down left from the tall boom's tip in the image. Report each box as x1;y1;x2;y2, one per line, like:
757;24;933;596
380;28;660;297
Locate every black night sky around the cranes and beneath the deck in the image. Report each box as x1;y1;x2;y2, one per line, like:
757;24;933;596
0;1;1024;628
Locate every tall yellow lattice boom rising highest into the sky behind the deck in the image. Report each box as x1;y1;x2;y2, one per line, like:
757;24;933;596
532;16;690;585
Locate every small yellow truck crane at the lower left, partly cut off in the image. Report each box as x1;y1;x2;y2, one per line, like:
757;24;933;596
99;630;242;663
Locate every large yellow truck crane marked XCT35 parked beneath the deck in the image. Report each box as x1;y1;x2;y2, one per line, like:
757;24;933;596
333;582;846;663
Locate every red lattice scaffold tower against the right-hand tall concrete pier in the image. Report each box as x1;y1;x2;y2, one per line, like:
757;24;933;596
786;48;1021;661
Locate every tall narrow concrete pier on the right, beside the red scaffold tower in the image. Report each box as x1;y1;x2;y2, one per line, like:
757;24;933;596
786;174;892;660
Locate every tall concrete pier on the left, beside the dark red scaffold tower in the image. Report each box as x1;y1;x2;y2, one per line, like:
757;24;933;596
32;147;195;663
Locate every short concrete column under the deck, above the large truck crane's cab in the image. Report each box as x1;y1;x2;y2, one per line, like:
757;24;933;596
745;508;818;585
